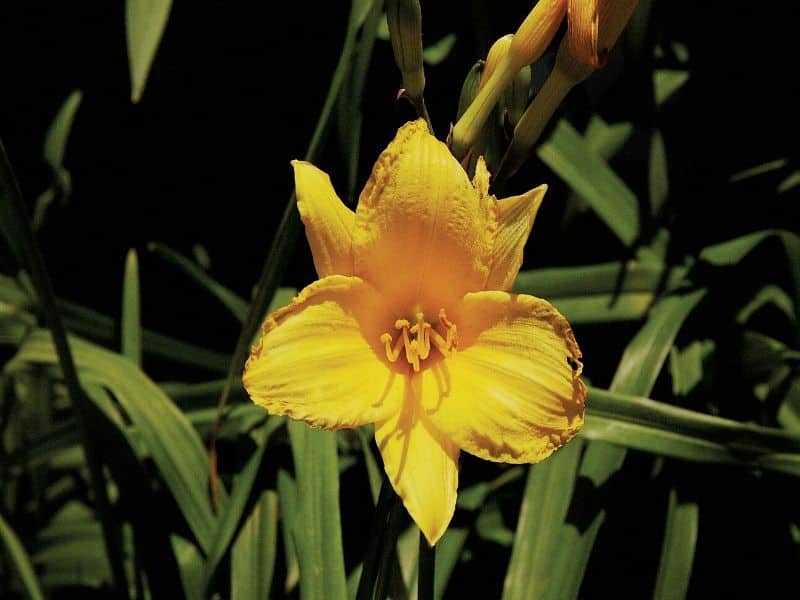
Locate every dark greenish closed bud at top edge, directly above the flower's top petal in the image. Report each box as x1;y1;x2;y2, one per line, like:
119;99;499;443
386;0;425;101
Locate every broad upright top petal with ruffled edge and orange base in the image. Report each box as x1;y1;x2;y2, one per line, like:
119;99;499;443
353;120;496;315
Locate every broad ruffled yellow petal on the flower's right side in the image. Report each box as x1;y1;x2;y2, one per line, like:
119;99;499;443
421;291;586;463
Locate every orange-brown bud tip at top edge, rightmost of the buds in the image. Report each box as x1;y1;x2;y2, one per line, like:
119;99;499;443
567;0;638;67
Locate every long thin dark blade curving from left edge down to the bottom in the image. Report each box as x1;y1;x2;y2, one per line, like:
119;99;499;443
0;140;128;598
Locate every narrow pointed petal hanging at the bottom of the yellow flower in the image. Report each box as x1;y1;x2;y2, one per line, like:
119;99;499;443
375;377;459;546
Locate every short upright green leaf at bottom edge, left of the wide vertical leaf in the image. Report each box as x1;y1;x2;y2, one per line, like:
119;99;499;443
231;490;278;600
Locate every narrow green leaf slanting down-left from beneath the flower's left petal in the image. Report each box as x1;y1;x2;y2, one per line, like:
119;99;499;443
204;418;285;597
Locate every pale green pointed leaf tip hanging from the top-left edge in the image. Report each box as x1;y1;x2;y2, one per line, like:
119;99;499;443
125;0;172;104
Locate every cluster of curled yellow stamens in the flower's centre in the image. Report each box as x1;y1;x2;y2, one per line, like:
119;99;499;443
381;308;458;372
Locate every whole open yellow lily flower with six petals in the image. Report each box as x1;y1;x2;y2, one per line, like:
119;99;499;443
243;120;586;545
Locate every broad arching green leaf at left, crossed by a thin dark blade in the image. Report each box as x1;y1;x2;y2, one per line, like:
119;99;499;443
6;330;216;552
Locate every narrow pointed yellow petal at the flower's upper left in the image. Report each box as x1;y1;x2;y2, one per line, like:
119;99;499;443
292;160;355;277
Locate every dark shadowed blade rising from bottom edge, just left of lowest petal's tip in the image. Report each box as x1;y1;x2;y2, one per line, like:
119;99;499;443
356;478;402;600
